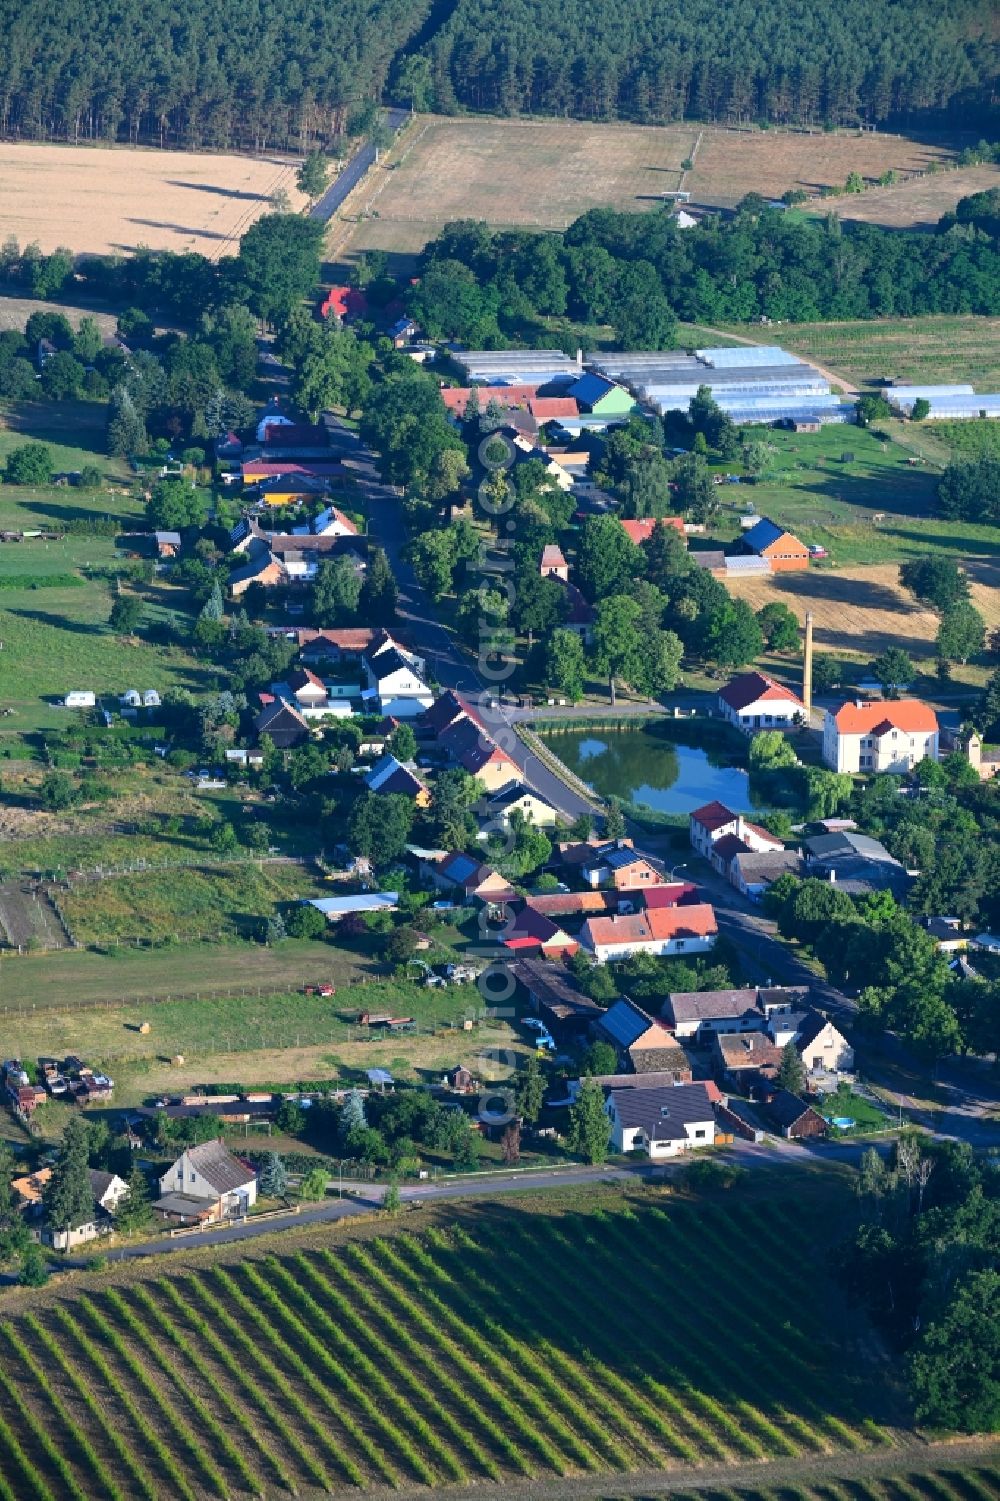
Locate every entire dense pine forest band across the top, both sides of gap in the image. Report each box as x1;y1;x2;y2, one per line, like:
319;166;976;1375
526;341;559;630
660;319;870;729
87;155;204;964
0;0;1000;150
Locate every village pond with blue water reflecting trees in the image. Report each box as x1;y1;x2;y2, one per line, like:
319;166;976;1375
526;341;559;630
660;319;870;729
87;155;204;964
542;720;757;814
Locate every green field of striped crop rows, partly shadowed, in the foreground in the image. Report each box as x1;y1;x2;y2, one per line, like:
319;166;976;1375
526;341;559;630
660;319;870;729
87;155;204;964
0;1186;902;1501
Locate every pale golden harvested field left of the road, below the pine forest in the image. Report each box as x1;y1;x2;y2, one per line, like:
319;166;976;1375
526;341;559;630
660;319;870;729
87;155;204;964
0;144;303;255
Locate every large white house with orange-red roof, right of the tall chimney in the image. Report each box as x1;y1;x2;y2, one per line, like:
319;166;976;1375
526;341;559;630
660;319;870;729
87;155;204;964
823;698;940;776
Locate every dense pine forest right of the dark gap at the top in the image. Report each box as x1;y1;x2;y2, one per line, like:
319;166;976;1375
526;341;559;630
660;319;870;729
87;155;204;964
417;0;997;125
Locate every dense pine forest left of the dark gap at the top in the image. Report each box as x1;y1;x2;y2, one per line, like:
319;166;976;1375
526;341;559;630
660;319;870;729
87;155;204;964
0;0;428;152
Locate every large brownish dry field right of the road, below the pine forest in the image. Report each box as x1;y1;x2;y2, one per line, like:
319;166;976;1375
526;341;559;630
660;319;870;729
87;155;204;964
330;117;958;258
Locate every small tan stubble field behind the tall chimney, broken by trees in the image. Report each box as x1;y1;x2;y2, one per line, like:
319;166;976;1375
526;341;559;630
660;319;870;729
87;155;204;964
727;558;1000;659
